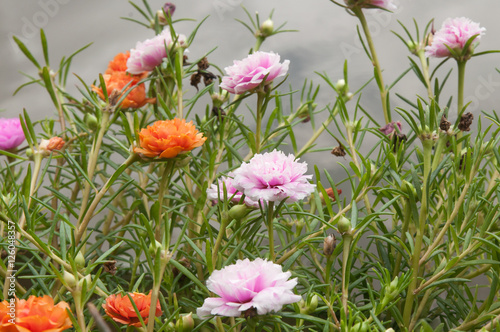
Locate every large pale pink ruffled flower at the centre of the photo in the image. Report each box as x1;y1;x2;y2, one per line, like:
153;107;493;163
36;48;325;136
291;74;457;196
233;150;314;203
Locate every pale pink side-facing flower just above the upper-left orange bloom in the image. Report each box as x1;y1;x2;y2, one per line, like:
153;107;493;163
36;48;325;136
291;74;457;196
127;28;186;75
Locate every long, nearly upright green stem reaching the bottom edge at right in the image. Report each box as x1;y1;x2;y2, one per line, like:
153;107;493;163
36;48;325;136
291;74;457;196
403;139;433;332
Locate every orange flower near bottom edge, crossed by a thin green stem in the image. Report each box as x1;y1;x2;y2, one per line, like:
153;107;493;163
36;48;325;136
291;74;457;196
102;292;162;327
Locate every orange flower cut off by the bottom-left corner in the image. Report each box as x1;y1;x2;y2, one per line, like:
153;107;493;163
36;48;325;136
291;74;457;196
0;295;73;332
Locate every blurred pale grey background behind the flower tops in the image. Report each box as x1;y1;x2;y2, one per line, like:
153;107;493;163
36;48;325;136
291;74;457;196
0;0;500;169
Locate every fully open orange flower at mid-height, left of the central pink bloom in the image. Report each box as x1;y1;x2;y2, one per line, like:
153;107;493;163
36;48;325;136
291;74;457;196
134;118;207;158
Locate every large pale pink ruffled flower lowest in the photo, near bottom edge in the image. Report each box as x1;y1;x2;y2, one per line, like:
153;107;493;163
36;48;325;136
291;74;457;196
196;258;301;318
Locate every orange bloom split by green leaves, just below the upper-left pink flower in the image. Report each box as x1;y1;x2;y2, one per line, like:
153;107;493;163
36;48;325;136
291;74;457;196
92;72;156;108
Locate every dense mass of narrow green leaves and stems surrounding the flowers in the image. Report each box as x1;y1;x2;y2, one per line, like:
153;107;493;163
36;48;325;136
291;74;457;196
0;1;500;332
